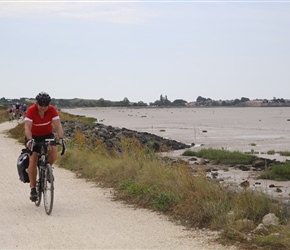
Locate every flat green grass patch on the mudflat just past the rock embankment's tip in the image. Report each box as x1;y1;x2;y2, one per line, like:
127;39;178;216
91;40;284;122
183;148;254;164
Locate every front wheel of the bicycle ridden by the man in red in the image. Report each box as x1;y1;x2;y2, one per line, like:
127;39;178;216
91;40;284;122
43;163;54;215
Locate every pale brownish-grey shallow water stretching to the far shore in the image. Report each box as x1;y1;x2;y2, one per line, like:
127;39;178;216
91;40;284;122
63;107;290;152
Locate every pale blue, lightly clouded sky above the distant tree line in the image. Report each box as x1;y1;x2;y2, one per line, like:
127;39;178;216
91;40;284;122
0;0;290;103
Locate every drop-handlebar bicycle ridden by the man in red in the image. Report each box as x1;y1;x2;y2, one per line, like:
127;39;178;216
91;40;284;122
31;139;66;215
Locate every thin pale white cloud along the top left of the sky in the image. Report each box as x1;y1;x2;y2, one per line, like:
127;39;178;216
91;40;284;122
0;1;155;24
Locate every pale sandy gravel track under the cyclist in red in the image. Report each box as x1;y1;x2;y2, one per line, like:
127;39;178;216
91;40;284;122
0;122;235;250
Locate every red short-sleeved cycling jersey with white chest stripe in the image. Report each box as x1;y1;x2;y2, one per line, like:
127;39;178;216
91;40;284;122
24;104;59;136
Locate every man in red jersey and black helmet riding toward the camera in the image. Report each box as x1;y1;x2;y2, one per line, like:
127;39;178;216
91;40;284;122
24;92;65;202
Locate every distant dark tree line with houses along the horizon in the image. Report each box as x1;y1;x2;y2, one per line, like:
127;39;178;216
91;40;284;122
0;95;290;108
